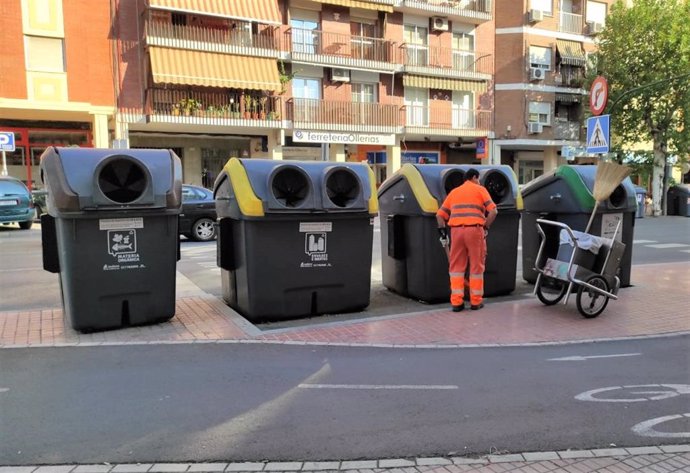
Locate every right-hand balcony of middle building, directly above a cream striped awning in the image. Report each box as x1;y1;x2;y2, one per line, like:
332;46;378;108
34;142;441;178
402;44;493;80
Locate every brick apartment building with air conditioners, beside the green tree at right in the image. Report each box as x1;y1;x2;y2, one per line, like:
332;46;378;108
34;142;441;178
493;0;614;184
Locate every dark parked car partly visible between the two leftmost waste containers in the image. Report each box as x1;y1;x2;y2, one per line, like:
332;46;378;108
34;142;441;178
180;184;216;241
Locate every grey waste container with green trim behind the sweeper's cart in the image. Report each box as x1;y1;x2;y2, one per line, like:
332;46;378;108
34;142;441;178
522;165;637;287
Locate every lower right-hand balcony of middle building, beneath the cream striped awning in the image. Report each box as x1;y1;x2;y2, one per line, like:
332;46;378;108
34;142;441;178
405;103;492;136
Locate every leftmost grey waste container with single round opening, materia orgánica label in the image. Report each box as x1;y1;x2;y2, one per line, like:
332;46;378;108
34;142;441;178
40;147;182;331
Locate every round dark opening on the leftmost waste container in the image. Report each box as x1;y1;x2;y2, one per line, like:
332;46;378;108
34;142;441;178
98;158;147;204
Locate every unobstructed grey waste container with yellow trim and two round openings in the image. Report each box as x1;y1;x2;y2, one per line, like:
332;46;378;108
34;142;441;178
214;158;378;321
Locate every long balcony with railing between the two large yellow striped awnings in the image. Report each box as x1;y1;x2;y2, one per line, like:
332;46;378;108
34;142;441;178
145;19;280;58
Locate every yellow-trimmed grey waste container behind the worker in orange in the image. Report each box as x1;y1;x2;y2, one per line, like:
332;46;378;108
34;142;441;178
378;164;522;302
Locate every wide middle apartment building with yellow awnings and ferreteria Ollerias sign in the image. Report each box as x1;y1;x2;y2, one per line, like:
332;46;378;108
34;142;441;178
112;0;495;186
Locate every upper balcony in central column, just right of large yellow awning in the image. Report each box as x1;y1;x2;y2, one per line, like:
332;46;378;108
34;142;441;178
285;28;400;73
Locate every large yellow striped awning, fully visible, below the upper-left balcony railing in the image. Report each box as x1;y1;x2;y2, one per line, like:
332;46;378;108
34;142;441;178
149;47;281;92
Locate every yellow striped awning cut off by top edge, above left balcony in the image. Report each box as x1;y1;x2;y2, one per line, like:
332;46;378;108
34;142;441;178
148;0;282;25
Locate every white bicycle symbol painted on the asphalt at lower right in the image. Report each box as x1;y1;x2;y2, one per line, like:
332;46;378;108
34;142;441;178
575;384;690;438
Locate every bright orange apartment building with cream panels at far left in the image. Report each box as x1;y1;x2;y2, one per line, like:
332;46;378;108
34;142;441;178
0;0;116;186
